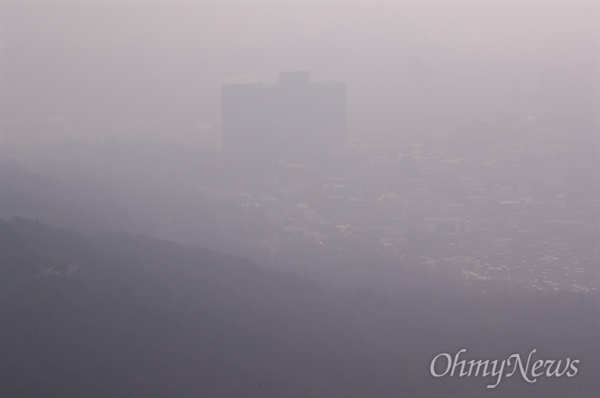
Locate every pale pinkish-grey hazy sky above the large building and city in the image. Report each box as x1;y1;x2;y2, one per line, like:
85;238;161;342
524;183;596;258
2;1;599;135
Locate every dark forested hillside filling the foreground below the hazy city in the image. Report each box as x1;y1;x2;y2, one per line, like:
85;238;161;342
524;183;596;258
0;219;598;397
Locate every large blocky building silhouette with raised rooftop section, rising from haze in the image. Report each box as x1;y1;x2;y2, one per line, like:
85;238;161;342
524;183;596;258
221;71;346;150
